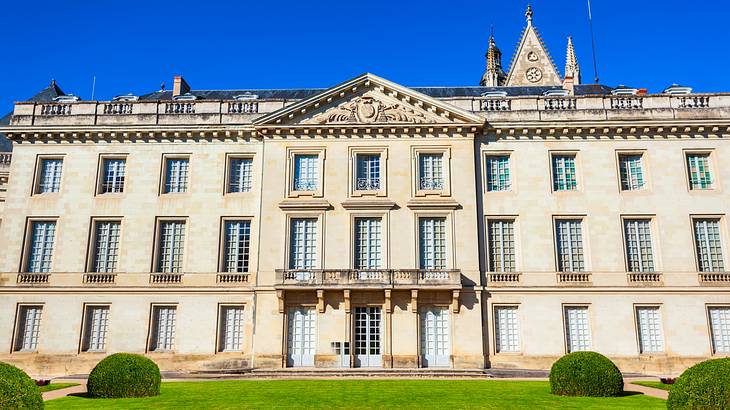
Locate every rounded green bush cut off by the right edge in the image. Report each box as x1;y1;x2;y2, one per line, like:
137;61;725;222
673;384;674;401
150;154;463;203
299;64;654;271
667;358;730;410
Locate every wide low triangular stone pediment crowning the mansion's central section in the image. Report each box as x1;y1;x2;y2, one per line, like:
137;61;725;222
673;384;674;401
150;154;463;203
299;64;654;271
254;73;484;126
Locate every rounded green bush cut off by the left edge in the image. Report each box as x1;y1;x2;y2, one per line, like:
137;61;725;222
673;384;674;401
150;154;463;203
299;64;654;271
0;362;43;410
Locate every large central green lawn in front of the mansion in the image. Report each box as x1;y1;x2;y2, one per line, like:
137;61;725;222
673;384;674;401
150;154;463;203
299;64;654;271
46;380;666;410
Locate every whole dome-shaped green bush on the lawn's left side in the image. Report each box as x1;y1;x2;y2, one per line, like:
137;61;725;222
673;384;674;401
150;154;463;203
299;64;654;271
86;353;160;398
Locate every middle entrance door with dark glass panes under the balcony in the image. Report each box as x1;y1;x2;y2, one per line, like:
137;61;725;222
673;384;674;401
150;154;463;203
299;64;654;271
355;307;383;367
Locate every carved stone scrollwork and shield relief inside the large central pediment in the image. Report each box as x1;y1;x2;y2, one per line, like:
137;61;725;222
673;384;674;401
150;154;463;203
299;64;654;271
302;96;428;124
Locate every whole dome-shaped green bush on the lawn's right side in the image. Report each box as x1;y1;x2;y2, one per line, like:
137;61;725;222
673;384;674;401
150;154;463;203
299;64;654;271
550;352;624;397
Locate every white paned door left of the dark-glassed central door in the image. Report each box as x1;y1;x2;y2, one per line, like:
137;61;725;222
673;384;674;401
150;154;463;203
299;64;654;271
287;308;315;367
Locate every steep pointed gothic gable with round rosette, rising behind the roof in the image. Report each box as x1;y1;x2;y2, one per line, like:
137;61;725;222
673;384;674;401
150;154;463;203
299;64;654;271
505;24;562;87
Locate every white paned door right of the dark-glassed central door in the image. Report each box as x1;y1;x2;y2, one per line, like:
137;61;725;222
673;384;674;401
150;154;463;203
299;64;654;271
421;307;451;367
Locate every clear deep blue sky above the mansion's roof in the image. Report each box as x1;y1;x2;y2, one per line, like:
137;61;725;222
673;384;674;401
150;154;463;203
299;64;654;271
0;0;730;113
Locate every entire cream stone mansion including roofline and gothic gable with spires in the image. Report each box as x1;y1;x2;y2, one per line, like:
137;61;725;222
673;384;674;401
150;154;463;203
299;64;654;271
0;9;730;375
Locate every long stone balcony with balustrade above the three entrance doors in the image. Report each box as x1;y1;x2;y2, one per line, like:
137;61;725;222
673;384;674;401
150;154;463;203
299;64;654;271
276;269;461;289
